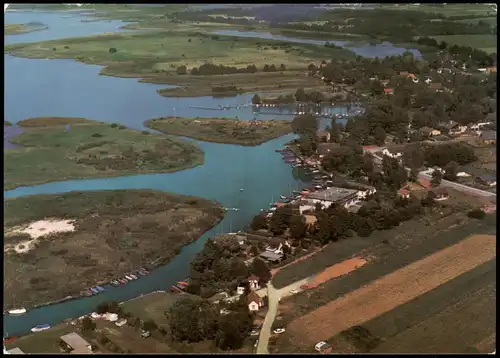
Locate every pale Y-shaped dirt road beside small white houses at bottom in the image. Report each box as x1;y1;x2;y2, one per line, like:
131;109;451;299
257;278;309;354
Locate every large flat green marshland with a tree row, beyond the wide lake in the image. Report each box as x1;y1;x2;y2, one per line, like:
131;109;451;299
5;30;355;97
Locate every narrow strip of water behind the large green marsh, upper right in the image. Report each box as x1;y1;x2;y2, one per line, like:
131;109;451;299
214;30;422;58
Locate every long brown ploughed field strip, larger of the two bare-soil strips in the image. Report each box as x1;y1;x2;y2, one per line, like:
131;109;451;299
289;235;496;344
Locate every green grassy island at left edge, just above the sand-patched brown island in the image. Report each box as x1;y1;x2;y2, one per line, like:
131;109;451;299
4;118;203;189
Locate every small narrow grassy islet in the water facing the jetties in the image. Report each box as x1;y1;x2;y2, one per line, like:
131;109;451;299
144;117;292;146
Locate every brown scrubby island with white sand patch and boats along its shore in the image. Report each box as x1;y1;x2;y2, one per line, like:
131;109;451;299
4;190;224;310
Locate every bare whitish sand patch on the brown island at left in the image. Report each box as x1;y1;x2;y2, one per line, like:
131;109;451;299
4;219;75;254
